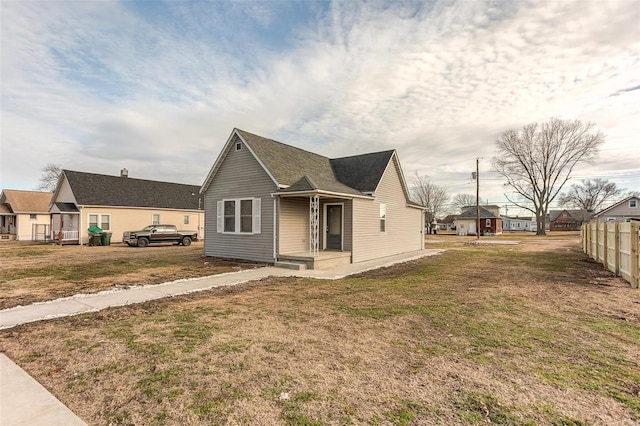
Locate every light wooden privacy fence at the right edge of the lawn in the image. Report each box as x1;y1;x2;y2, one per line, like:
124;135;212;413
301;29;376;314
581;221;640;288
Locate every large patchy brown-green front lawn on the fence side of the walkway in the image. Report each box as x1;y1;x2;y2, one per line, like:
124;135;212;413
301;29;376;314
0;237;640;425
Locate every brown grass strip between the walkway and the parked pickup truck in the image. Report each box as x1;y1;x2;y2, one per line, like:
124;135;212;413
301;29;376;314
0;243;258;309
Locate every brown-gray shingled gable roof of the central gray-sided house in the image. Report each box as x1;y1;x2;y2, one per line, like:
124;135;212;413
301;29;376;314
202;129;419;206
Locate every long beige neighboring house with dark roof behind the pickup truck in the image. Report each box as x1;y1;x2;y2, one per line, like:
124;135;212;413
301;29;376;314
49;169;204;244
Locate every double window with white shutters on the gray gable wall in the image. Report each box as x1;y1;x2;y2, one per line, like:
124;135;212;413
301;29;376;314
217;198;261;234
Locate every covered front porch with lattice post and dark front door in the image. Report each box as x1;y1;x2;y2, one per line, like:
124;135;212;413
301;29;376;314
276;193;353;270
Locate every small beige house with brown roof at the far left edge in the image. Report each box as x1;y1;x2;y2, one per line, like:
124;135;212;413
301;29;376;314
0;189;52;241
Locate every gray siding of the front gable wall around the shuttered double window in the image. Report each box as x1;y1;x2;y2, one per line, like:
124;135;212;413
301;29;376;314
204;140;276;262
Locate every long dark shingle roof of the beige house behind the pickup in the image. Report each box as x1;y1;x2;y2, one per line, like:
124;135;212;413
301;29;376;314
62;170;200;210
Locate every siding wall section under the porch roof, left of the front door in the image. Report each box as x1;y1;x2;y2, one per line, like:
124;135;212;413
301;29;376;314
278;198;309;253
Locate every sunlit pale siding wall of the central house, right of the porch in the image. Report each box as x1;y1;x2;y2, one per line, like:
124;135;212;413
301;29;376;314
352;161;424;262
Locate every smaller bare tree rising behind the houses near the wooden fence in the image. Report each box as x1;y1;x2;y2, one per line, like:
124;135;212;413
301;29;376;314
558;178;622;211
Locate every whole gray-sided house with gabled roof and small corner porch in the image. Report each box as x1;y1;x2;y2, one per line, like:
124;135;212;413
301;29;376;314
202;129;424;269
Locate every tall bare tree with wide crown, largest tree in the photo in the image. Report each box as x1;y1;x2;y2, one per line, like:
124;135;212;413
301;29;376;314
493;118;604;235
